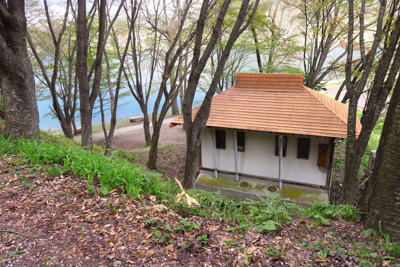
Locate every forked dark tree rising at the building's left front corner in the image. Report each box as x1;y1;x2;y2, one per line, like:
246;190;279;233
183;0;259;188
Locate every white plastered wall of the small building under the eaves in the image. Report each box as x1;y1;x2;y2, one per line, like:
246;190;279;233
201;128;329;186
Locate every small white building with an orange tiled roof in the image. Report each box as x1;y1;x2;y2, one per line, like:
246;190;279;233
170;73;361;203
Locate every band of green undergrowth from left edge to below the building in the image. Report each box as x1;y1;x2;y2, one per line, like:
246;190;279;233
0;134;400;258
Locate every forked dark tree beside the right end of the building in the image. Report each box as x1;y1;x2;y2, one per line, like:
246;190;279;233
342;1;400;205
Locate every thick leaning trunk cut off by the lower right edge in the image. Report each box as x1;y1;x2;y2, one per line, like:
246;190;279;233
362;76;400;241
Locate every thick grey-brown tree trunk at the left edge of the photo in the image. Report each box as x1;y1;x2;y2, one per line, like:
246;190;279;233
0;0;39;138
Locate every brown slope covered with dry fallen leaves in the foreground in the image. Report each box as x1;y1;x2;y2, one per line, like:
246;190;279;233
0;156;400;266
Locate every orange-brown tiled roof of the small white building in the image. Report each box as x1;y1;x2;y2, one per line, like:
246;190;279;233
170;73;361;138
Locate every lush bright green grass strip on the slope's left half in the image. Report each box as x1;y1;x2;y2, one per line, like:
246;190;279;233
0;134;167;197
